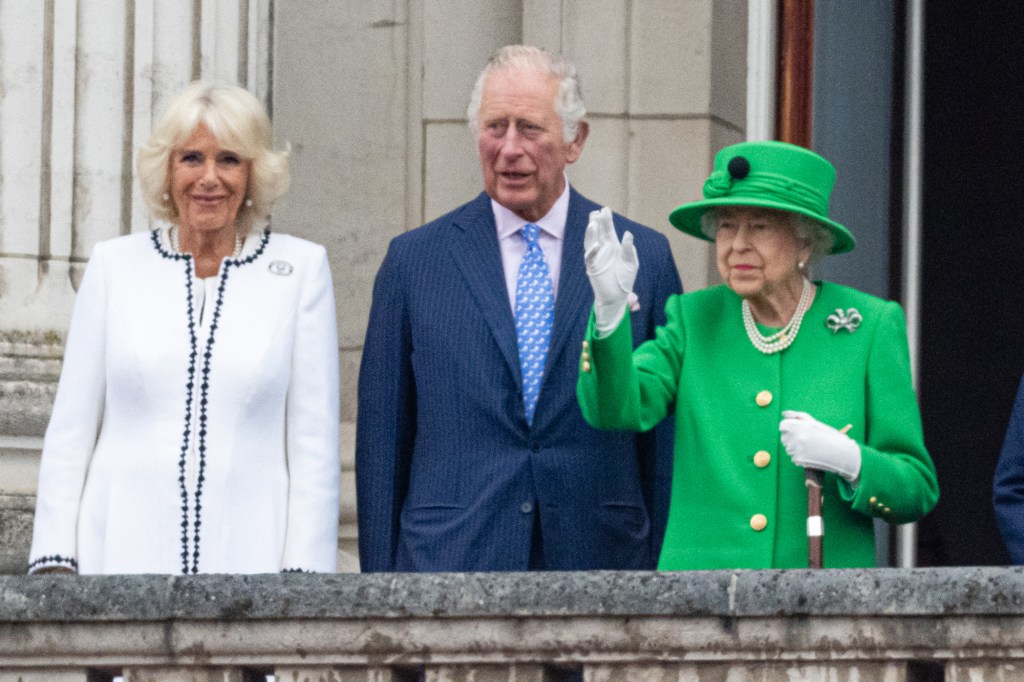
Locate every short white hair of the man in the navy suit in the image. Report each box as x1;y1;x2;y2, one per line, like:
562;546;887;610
466;45;587;142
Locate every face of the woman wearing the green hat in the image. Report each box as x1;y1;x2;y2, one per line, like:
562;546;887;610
715;207;811;300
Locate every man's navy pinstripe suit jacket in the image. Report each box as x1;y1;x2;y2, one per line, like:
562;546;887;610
355;190;681;571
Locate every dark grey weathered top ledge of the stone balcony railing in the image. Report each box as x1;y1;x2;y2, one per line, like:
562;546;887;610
0;567;1024;623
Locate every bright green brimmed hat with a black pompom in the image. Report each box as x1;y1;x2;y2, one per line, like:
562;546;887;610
669;140;854;253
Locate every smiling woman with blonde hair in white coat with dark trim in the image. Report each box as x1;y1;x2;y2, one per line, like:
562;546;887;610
29;83;339;573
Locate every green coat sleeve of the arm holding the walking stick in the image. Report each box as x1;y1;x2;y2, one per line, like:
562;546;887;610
841;303;939;523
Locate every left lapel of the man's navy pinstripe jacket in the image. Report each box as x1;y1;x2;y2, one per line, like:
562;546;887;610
452;194;524;384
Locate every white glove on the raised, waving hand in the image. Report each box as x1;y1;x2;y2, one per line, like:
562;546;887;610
583;206;640;336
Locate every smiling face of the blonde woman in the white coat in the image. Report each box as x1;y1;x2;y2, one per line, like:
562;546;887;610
171;123;250;237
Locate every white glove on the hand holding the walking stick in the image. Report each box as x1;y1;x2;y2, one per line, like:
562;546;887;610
778;410;860;483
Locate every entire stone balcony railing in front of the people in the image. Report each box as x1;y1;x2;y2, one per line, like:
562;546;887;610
0;568;1024;682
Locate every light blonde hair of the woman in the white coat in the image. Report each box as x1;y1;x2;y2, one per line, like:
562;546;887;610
135;81;290;232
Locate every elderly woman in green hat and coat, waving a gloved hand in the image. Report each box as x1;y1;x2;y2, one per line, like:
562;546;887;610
578;141;939;569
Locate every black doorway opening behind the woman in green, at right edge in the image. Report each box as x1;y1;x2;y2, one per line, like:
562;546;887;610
919;0;1024;565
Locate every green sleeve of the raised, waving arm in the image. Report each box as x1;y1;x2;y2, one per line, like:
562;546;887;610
577;296;683;431
